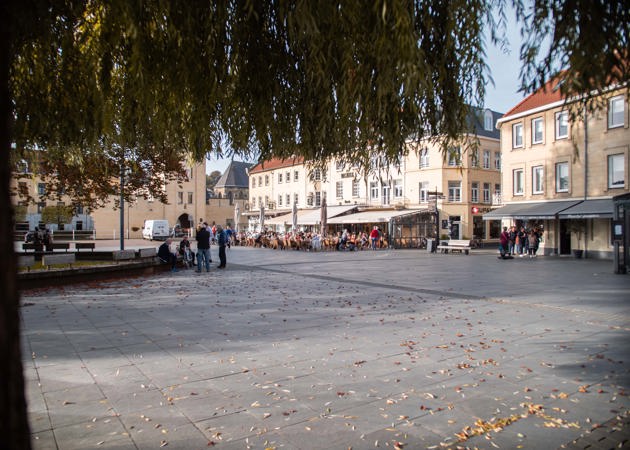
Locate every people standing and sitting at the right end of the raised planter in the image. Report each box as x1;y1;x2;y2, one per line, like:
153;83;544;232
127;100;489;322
158;222;232;273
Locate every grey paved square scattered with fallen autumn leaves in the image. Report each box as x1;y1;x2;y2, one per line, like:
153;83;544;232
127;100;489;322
22;248;630;449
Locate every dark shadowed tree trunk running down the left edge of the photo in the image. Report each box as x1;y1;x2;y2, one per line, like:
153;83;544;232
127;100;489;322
0;0;31;450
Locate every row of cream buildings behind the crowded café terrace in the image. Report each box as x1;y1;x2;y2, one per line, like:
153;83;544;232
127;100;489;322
248;110;501;243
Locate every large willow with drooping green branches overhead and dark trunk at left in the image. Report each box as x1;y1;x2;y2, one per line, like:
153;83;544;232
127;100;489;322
0;0;630;448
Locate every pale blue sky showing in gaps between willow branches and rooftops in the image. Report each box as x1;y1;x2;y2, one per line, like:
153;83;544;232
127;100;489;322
206;10;523;173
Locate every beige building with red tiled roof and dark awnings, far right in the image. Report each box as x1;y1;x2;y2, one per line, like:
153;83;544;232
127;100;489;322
492;79;630;258
